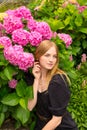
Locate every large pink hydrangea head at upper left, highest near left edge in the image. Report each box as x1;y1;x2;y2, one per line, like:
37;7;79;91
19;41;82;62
3;15;23;34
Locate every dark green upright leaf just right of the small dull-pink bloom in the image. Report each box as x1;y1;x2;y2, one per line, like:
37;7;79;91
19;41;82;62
16;79;27;97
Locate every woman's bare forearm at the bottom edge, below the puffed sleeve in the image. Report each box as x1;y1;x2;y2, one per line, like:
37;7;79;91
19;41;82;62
42;116;62;130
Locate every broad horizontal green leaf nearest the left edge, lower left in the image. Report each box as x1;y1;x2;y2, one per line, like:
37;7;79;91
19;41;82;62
1;93;19;106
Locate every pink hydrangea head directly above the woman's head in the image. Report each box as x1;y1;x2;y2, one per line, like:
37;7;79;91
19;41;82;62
35;22;52;40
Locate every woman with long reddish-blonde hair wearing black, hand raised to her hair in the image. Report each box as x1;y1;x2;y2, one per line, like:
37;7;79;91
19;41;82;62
28;40;77;130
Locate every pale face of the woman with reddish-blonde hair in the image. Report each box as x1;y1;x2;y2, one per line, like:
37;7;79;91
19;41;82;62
39;46;57;70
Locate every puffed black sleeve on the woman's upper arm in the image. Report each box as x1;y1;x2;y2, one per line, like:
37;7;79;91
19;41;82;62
48;74;70;116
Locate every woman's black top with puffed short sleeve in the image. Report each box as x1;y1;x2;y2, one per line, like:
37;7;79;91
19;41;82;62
36;74;76;130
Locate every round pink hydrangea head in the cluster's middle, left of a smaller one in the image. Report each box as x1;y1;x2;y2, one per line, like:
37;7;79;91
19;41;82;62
12;29;29;46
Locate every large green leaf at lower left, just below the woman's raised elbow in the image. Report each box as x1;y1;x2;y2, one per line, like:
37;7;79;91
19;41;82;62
16;106;30;124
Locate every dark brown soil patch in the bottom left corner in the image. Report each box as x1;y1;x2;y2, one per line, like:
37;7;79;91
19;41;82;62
0;119;29;130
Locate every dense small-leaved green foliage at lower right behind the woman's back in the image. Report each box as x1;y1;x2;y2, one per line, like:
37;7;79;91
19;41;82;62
68;72;87;130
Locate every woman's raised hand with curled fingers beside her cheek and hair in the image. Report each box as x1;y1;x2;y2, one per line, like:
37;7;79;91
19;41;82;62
32;62;41;79
